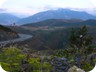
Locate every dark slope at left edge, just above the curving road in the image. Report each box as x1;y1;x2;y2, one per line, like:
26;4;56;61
0;25;19;41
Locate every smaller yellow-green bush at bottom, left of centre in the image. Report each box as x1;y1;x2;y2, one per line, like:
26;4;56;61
29;58;52;72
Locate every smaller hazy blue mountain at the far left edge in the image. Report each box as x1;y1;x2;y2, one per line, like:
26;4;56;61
0;13;20;25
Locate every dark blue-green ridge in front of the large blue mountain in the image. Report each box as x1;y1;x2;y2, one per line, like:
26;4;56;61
23;19;96;27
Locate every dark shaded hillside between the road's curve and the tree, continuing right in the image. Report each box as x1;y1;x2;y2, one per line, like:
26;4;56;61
15;27;96;50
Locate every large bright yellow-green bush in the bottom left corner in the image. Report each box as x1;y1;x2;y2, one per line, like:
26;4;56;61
0;47;26;72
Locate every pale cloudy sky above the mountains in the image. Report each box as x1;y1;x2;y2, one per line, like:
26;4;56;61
0;0;96;17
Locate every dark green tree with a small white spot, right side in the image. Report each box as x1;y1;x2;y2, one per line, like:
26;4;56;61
69;26;92;55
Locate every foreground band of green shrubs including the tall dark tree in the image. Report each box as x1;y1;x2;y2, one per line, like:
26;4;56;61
0;26;96;72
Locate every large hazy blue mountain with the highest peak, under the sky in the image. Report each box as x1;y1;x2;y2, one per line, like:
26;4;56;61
17;8;96;24
